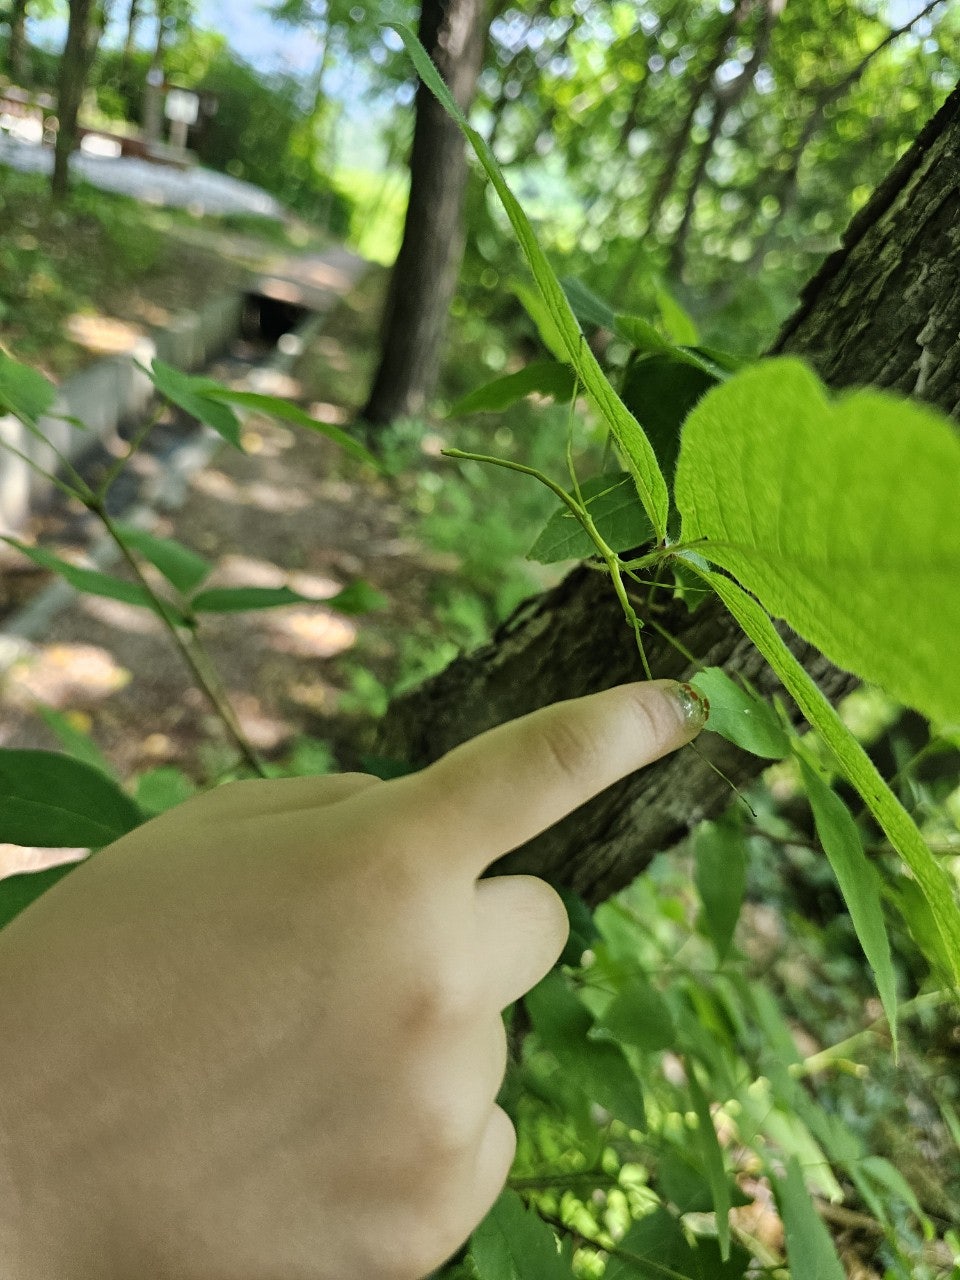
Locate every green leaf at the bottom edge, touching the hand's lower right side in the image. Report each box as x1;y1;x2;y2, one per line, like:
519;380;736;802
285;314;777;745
470;1190;573;1280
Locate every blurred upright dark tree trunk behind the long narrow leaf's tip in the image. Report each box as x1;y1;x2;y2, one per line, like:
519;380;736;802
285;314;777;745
361;0;486;424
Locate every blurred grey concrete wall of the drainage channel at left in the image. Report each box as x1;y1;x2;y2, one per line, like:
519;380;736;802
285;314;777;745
0;293;243;536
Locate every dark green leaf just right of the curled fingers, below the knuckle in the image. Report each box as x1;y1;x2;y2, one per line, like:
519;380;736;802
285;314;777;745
524;969;646;1129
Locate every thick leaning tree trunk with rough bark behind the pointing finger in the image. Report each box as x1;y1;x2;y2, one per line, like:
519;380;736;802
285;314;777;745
379;90;960;902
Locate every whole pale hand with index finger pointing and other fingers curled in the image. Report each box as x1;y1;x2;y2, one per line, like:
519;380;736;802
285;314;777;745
0;681;704;1280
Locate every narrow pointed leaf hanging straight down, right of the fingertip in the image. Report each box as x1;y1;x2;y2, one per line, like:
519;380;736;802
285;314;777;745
797;753;897;1039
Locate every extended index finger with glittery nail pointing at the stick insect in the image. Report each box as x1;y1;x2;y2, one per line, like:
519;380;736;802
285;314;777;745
379;680;708;876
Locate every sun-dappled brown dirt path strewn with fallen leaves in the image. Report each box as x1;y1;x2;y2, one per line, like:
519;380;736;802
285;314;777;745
0;264;465;872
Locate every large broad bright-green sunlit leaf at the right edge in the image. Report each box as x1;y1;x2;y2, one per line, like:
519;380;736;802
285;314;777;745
676;360;960;721
